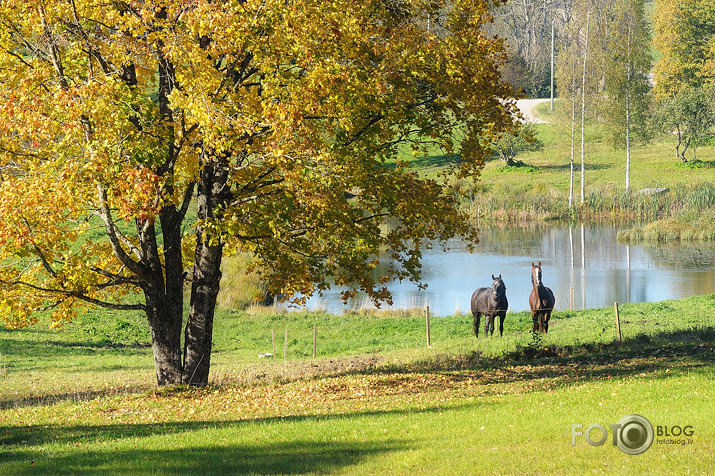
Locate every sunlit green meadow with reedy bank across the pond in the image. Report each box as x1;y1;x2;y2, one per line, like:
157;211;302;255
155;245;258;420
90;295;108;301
428;102;715;234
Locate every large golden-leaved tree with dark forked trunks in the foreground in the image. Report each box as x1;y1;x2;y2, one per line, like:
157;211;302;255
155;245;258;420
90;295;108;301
0;0;514;385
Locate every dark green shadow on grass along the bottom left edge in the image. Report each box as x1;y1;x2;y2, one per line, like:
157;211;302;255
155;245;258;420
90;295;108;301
0;434;408;475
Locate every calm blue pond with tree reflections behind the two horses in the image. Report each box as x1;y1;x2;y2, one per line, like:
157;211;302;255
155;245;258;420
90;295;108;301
307;225;715;316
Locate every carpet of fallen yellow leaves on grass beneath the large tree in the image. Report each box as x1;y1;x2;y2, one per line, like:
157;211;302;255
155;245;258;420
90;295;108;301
81;362;510;422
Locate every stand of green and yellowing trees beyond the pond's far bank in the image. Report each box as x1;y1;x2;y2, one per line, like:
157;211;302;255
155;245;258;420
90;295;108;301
489;0;715;197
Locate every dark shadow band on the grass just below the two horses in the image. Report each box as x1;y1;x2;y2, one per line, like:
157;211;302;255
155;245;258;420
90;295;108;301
338;327;715;390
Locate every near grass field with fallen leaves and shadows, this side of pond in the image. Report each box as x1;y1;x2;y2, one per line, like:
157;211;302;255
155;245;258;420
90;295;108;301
0;295;715;474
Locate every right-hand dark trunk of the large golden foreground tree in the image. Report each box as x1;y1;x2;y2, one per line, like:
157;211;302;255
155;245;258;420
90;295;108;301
182;156;229;386
